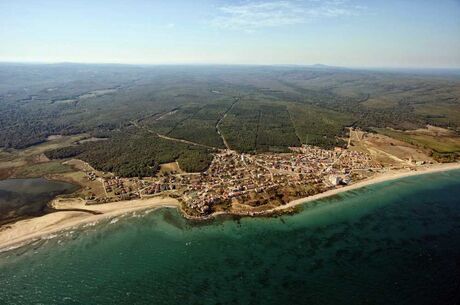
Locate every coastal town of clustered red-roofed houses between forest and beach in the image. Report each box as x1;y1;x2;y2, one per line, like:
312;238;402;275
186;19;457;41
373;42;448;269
78;145;383;217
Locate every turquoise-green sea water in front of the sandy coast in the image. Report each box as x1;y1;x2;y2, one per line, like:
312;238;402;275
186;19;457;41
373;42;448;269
0;171;460;305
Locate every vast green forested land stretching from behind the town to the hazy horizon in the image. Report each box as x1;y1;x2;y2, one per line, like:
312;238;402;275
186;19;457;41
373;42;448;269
0;64;460;176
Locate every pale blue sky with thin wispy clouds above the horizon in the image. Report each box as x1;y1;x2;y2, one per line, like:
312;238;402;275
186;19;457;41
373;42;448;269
0;0;460;68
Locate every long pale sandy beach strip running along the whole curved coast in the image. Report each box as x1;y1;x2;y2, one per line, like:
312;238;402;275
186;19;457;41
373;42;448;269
0;163;460;252
